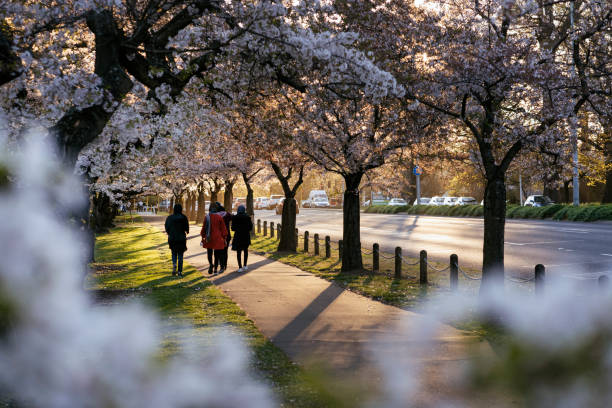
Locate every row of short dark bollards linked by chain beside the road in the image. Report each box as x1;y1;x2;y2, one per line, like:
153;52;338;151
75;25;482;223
252;220;588;294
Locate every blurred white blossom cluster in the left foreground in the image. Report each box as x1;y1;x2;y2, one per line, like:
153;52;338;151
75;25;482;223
0;134;276;408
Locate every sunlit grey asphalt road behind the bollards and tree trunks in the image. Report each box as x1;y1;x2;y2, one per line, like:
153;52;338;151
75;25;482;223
255;209;612;279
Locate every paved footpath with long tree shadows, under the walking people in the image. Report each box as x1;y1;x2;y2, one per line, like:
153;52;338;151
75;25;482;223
145;217;506;407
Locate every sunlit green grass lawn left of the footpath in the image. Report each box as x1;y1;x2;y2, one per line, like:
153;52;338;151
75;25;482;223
86;223;353;407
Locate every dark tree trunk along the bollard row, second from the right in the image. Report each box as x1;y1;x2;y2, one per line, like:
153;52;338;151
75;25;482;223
342;173;363;272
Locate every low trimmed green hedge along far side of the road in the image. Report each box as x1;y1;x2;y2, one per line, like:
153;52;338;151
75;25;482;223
365;204;612;221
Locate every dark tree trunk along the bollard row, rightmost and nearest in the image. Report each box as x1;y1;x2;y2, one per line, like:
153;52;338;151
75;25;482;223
480;170;506;292
